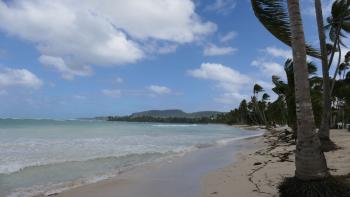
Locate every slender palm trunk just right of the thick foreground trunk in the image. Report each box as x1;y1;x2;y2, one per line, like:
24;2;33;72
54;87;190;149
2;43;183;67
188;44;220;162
315;0;331;140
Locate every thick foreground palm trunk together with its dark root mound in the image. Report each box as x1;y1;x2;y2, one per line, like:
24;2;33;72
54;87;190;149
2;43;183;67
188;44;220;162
279;0;343;197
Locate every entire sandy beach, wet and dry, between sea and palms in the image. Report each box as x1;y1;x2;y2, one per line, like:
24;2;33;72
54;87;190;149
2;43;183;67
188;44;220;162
45;128;350;197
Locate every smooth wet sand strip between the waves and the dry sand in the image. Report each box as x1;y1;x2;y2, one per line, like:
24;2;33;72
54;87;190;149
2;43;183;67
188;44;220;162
44;127;263;197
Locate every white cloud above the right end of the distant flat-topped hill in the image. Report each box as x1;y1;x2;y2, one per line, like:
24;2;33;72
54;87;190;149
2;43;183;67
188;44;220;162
188;63;252;104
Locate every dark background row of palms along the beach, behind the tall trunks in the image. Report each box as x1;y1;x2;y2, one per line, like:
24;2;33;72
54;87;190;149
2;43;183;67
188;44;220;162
216;57;350;131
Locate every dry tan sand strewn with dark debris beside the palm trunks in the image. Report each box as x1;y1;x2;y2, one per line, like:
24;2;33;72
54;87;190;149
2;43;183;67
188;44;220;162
202;130;350;197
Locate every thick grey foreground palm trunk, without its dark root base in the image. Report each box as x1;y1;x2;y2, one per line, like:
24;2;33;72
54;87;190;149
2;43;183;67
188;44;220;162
288;0;329;180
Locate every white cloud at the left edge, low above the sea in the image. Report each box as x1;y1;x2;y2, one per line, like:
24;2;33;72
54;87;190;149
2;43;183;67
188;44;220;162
0;68;43;89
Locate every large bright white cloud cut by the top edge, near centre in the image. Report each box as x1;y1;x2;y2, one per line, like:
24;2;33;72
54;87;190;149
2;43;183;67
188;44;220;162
94;0;216;43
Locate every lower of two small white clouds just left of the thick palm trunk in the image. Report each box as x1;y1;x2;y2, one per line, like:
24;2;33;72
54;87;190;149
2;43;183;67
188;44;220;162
252;60;285;77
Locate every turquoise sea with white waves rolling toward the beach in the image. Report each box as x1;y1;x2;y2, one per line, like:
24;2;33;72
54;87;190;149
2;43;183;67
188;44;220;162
0;119;261;197
